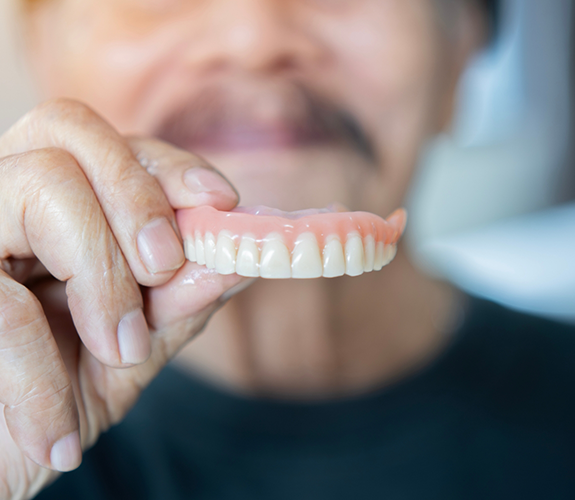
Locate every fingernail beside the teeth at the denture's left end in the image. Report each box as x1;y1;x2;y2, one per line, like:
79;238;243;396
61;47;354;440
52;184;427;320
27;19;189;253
138;218;185;274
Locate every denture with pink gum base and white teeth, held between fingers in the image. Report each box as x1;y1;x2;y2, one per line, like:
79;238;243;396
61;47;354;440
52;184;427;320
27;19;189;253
177;207;406;279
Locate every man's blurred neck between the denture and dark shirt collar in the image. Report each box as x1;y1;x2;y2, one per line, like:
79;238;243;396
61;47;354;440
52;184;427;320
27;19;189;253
177;251;464;399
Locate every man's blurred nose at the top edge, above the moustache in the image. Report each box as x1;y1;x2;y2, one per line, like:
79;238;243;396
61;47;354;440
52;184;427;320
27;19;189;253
189;0;323;72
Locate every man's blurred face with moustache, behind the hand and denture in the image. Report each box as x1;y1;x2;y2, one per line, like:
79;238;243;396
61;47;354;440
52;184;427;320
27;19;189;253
31;0;479;215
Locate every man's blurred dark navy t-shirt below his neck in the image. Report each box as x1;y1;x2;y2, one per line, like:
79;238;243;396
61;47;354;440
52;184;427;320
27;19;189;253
38;299;575;500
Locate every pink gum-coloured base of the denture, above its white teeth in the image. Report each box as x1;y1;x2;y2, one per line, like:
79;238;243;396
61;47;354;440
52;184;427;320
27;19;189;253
176;206;407;250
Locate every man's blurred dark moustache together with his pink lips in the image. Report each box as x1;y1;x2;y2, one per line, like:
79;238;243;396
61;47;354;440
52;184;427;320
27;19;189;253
155;79;368;155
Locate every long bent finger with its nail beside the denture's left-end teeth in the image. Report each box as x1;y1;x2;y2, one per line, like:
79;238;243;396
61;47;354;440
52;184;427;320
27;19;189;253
0;99;185;286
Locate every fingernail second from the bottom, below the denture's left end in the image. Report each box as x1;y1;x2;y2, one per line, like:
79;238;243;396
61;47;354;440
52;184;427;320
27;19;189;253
118;309;151;365
